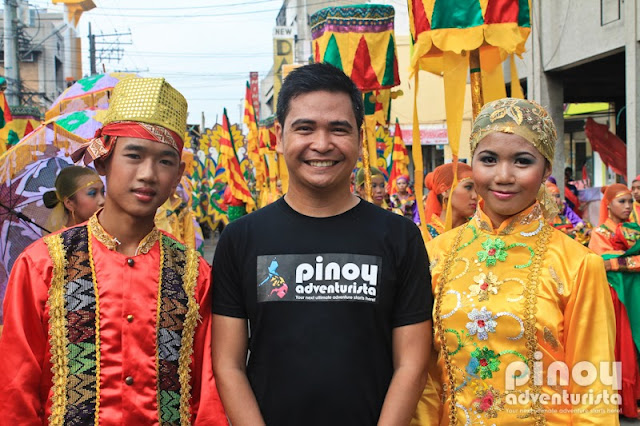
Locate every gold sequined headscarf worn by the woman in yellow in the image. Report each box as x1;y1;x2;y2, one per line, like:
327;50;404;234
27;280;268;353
470;98;558;218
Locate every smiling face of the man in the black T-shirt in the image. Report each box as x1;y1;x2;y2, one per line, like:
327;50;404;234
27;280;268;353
276;91;361;197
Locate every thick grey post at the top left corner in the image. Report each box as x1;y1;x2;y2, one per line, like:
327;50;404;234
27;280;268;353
4;0;20;105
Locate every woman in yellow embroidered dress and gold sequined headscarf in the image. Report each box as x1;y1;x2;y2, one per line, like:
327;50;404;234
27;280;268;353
414;98;619;425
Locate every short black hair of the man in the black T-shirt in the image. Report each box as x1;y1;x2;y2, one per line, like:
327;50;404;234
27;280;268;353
276;63;364;129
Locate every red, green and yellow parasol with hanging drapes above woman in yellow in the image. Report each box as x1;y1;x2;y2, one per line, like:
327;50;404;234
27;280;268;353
408;0;531;228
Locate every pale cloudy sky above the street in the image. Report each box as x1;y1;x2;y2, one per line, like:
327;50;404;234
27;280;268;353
29;0;408;127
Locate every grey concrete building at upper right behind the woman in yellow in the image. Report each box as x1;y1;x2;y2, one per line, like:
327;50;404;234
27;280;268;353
516;0;640;186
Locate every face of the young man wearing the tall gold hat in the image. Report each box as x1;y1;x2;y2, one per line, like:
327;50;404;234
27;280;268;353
96;137;184;220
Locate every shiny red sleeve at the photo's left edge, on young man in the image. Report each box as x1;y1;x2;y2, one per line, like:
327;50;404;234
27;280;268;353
0;245;51;426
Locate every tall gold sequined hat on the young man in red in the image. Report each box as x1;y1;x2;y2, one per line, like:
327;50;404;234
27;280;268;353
104;78;187;138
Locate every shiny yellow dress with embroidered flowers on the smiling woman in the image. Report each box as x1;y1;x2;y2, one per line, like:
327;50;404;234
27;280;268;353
412;203;618;425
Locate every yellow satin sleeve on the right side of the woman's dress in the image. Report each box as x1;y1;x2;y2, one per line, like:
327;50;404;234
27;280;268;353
564;253;619;425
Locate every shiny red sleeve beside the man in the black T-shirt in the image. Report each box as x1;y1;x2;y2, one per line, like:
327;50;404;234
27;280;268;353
191;258;229;426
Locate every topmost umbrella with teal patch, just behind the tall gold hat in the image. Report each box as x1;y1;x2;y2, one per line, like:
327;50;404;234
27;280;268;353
44;72;137;120
